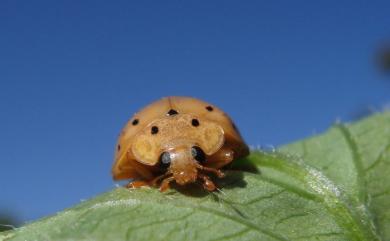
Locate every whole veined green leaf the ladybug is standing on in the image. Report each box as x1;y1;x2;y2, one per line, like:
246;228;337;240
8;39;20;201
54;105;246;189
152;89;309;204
0;113;390;241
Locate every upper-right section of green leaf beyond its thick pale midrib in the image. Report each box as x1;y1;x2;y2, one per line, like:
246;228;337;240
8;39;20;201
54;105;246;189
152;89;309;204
282;113;390;240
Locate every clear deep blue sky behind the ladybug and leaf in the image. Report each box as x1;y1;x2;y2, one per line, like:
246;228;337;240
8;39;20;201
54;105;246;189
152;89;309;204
0;0;390;225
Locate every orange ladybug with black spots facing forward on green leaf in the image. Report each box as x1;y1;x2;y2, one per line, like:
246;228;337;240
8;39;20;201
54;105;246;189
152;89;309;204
112;96;249;191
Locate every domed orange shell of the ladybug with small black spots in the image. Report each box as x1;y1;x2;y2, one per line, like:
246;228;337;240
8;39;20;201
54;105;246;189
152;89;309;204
112;96;249;180
